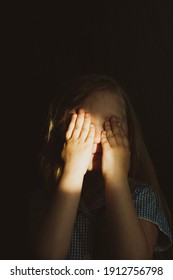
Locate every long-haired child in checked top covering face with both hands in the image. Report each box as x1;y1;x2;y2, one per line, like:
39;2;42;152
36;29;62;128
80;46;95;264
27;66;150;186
31;74;172;259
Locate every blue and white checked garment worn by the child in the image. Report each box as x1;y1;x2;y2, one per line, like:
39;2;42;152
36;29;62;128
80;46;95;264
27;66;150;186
30;180;172;260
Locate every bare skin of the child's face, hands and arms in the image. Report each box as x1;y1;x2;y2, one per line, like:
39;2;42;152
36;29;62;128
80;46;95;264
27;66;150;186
32;92;158;259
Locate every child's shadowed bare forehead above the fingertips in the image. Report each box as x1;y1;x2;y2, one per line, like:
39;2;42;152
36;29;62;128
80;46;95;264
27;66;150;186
83;90;125;118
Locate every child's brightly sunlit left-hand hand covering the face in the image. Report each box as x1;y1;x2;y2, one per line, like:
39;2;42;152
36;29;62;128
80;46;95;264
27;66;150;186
61;109;95;176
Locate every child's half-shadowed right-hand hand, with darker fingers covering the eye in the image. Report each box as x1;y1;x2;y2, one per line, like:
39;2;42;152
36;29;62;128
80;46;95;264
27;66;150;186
101;117;130;183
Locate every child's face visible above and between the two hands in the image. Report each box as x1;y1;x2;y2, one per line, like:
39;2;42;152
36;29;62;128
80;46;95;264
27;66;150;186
82;91;127;171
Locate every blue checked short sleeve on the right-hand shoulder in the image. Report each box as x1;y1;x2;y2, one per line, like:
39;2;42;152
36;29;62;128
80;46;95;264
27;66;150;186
129;179;172;251
